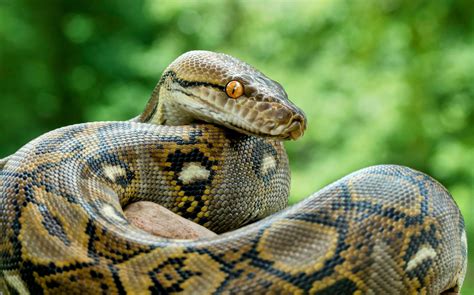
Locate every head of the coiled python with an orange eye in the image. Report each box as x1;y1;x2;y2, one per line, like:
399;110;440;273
142;51;306;139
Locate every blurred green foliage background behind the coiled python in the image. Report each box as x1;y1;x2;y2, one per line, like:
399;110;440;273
0;0;474;294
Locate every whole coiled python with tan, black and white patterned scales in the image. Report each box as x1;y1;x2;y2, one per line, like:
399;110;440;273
0;51;467;294
